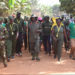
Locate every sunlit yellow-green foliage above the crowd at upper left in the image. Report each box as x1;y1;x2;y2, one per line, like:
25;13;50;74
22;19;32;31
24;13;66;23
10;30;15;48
0;0;31;16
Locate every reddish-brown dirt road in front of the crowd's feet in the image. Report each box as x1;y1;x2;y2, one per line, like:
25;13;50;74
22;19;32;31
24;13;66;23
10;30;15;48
0;47;75;75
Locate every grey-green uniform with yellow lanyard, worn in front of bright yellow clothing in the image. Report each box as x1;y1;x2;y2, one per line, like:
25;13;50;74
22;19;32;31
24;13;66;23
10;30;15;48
53;26;64;61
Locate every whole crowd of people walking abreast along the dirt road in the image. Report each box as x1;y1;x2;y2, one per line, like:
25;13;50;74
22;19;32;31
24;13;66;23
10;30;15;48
0;12;75;67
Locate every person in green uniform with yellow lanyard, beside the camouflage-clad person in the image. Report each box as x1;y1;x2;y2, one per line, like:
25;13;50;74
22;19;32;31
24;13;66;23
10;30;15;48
6;16;18;61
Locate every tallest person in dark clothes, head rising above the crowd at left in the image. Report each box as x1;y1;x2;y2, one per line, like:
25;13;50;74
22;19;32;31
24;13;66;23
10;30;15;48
14;12;25;56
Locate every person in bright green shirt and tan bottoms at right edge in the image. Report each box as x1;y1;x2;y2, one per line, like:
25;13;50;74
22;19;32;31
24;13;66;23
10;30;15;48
69;20;75;59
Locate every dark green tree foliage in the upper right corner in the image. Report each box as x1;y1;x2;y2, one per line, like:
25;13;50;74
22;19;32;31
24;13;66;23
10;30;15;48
59;0;75;15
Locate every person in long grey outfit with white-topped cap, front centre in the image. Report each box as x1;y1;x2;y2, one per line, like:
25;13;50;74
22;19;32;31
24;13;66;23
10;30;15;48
29;16;40;61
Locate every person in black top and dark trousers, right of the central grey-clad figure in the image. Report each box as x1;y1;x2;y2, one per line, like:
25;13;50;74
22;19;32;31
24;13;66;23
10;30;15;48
42;16;51;55
